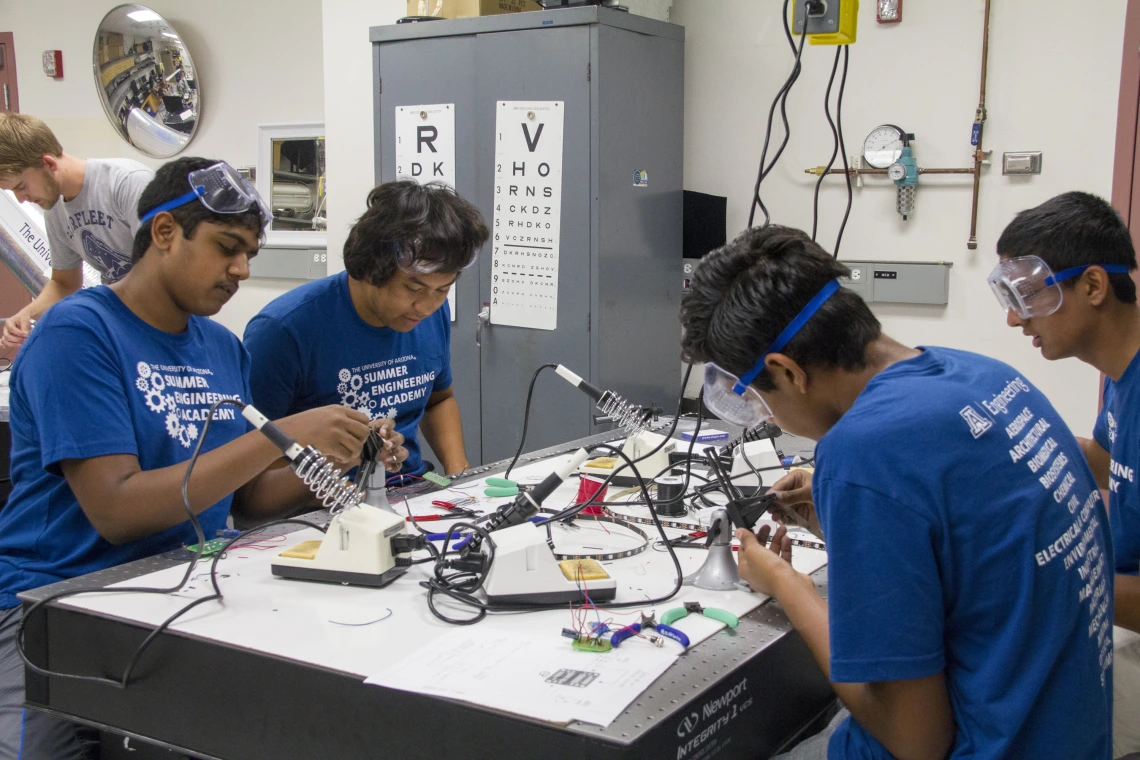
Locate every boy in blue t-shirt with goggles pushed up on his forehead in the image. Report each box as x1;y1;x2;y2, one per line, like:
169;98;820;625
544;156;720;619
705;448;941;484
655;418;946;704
0;158;399;760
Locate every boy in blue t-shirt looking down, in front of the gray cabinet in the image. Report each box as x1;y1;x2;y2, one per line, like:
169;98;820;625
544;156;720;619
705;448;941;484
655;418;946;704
244;180;489;475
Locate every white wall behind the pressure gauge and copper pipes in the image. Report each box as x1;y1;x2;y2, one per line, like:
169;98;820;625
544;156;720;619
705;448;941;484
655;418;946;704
671;0;1125;435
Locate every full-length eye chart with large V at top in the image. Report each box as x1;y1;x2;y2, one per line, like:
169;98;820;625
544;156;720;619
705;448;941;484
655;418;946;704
491;100;564;329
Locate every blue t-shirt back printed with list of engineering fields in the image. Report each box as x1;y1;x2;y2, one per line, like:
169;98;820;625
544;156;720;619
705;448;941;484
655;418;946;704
813;348;1113;760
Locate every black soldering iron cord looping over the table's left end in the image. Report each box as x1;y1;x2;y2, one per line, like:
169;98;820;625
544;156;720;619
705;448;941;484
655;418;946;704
16;399;245;689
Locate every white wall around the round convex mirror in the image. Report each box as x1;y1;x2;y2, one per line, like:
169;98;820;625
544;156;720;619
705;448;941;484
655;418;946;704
0;0;325;335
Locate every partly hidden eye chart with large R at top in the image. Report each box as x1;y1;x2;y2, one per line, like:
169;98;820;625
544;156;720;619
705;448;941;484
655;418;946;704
396;103;455;322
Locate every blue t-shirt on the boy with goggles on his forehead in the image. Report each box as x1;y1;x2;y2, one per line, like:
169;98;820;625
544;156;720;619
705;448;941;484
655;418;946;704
0;286;250;608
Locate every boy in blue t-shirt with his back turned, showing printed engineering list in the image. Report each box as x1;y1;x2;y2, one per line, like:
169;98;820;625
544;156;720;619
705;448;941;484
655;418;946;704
682;226;1113;760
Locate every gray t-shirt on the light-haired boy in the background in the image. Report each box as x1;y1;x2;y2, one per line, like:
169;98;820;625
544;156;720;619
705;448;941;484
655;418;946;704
44;158;154;285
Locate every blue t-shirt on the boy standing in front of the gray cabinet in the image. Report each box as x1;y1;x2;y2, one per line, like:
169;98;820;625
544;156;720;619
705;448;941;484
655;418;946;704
245;272;451;475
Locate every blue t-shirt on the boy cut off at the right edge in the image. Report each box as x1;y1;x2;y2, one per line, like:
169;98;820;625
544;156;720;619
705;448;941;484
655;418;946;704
1092;353;1140;575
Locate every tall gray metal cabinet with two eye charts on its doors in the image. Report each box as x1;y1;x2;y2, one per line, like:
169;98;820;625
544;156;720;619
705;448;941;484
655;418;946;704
371;7;684;464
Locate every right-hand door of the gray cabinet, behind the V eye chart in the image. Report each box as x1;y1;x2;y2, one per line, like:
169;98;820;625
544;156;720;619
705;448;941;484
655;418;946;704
473;26;592;461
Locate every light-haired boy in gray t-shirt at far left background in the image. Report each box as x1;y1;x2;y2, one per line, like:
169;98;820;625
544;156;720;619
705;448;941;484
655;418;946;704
0;113;154;349
